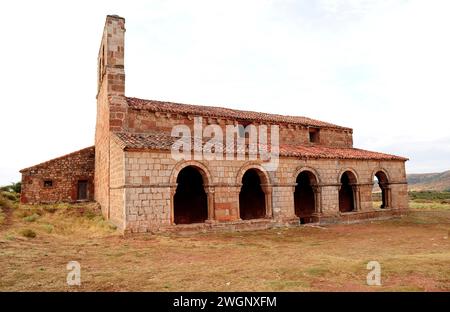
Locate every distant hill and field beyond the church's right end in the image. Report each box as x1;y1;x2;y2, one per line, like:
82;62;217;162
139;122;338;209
406;170;450;191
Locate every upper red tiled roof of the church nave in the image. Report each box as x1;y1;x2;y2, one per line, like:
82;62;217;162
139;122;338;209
127;97;352;131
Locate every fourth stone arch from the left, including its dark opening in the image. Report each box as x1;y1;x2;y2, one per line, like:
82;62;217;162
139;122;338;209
338;169;360;212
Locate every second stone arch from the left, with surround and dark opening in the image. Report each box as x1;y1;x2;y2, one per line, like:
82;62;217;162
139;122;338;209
236;163;272;220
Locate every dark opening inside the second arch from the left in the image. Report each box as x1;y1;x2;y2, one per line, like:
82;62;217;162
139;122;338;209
239;169;266;220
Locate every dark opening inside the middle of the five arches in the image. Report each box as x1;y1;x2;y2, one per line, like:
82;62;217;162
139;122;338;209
294;171;317;224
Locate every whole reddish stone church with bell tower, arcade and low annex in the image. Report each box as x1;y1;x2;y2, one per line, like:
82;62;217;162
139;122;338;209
21;15;408;233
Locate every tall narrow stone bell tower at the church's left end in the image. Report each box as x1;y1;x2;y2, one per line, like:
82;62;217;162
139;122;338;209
95;15;127;219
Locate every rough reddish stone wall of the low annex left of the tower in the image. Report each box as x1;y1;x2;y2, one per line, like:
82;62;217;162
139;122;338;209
20;147;95;204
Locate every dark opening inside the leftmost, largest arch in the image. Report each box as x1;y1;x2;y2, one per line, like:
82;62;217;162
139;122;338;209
173;166;208;224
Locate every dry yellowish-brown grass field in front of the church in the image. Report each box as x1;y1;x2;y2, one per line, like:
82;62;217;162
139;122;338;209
0;193;450;291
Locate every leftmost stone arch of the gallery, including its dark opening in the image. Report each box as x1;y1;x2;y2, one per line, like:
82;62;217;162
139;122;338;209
169;160;214;224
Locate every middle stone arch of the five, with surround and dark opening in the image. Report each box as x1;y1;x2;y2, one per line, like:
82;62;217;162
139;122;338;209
294;167;321;224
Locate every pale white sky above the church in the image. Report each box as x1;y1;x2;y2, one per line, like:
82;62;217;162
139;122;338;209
0;0;450;185
